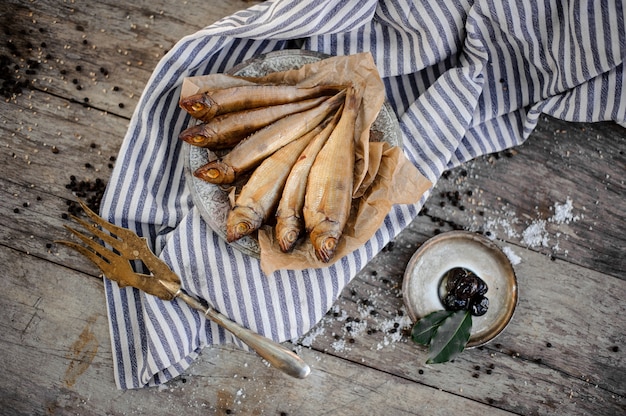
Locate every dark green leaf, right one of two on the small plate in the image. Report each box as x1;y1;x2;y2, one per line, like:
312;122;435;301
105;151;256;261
426;310;472;364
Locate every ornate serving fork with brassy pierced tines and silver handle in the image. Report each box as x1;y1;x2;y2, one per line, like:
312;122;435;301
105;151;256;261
57;201;311;378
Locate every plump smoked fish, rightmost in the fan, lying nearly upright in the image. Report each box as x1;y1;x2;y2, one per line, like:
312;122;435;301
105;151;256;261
303;87;361;263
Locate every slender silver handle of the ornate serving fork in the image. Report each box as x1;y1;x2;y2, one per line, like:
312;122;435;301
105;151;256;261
174;289;311;378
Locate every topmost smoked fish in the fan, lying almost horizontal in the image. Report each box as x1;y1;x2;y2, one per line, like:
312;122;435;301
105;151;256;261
179;85;343;122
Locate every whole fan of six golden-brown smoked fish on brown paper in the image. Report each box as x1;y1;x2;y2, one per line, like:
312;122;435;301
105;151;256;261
179;84;362;263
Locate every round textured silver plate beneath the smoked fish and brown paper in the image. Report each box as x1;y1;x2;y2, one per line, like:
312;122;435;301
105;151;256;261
183;50;402;258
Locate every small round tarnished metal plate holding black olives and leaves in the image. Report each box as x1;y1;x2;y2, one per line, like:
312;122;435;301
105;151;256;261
402;231;517;347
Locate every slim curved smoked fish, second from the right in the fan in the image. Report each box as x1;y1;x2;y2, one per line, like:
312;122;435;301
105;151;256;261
274;108;341;253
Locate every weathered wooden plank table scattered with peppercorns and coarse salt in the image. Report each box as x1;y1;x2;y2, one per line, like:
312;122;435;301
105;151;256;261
0;0;626;415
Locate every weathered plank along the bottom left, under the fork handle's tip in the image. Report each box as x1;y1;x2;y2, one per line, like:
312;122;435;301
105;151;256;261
0;247;508;415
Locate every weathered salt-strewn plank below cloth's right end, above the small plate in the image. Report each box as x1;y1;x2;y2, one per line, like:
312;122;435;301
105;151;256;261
420;117;626;279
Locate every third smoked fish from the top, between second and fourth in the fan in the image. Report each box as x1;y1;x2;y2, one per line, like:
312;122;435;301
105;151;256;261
194;90;346;184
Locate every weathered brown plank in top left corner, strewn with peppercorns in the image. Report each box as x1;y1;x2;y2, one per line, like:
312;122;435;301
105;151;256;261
0;0;258;118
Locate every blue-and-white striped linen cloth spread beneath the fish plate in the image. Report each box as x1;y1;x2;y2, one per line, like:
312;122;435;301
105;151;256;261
101;0;626;389
